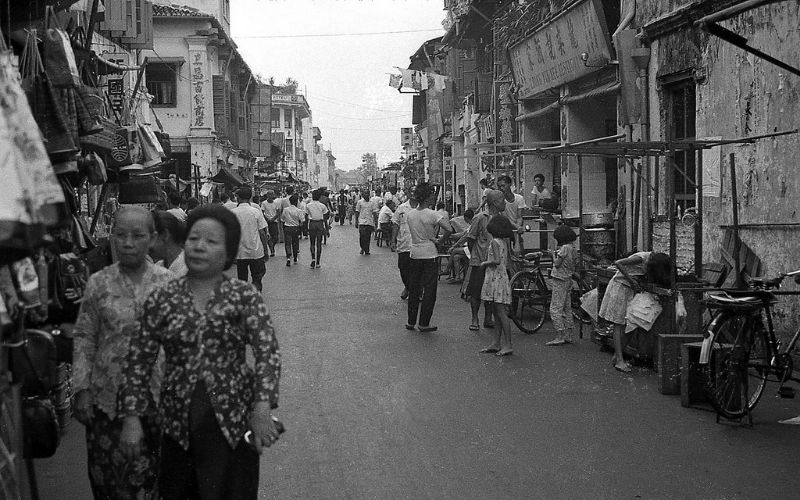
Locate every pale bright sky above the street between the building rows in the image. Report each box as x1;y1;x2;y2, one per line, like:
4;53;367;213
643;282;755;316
231;0;444;170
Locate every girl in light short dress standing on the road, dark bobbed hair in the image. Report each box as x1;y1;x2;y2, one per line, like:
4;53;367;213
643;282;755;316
480;215;514;356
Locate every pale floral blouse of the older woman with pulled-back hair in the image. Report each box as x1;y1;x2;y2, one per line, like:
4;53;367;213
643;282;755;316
72;263;175;419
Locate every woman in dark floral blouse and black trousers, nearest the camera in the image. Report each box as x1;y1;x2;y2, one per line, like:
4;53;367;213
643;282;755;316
122;205;280;500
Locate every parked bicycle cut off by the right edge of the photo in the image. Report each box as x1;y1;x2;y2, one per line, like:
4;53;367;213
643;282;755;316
700;270;800;423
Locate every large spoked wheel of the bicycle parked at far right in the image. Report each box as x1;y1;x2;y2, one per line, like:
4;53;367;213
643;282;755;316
703;314;769;419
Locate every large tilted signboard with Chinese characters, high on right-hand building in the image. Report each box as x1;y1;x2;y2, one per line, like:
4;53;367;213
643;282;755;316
509;0;611;99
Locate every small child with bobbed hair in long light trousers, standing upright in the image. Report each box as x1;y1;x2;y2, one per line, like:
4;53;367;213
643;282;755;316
545;225;578;345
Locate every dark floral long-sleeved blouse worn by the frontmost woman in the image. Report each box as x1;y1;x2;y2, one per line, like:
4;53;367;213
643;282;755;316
123;277;281;449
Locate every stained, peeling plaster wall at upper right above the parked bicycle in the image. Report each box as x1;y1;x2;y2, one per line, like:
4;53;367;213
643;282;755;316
697;2;800;336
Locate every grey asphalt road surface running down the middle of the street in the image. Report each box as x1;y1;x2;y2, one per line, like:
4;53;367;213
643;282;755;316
37;225;800;500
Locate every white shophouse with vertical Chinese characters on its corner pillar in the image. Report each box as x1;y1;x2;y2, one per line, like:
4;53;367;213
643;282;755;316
145;1;270;189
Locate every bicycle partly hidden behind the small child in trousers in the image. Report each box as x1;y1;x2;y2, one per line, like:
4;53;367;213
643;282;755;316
510;252;592;334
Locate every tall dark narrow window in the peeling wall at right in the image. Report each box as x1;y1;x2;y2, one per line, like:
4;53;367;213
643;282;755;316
665;80;697;211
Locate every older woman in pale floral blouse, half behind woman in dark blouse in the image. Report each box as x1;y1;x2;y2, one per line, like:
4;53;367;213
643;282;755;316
72;207;173;500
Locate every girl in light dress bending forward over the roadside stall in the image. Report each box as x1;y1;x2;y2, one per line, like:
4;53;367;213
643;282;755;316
598;252;673;373
